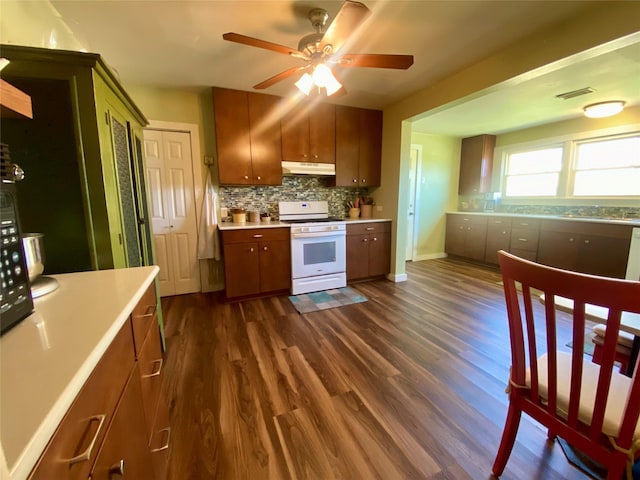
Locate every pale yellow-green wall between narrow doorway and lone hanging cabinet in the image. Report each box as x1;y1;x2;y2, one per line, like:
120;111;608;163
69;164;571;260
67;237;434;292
411;132;460;260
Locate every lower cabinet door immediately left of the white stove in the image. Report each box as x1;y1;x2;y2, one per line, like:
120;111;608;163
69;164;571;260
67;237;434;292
260;240;291;292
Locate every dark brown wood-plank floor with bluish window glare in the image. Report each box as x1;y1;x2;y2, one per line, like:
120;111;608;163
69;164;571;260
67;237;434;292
162;259;587;480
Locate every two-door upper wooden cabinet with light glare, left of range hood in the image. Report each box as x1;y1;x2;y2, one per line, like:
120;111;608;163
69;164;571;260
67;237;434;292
213;88;282;185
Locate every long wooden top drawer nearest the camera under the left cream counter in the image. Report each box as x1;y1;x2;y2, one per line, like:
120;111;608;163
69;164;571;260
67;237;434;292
29;321;134;480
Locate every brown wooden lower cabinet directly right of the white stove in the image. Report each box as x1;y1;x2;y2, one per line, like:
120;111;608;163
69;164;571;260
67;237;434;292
347;222;391;281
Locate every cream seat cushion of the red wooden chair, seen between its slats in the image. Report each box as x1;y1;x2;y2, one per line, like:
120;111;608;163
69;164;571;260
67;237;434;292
527;352;640;446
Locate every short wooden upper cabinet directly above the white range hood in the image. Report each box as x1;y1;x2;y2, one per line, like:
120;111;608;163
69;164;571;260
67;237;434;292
282;103;336;163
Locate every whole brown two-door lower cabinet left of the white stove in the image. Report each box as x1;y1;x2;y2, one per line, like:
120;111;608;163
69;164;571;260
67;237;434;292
222;228;291;298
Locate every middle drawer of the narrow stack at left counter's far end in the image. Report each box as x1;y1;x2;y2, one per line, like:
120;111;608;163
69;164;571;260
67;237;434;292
139;322;164;439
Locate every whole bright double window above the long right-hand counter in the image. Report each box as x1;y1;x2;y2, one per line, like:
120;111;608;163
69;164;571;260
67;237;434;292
501;130;640;199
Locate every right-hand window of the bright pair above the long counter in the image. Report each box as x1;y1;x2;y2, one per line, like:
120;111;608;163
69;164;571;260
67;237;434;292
573;135;640;197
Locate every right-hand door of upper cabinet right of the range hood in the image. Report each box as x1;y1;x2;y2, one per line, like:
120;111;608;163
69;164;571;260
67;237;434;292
359;109;382;187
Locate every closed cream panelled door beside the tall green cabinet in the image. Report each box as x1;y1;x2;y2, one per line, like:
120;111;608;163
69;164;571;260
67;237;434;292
144;130;200;297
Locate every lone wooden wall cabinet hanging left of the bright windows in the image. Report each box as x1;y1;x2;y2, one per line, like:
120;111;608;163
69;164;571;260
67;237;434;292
458;135;496;195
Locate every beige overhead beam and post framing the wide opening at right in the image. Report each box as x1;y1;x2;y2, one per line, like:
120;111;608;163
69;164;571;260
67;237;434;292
374;2;640;279
